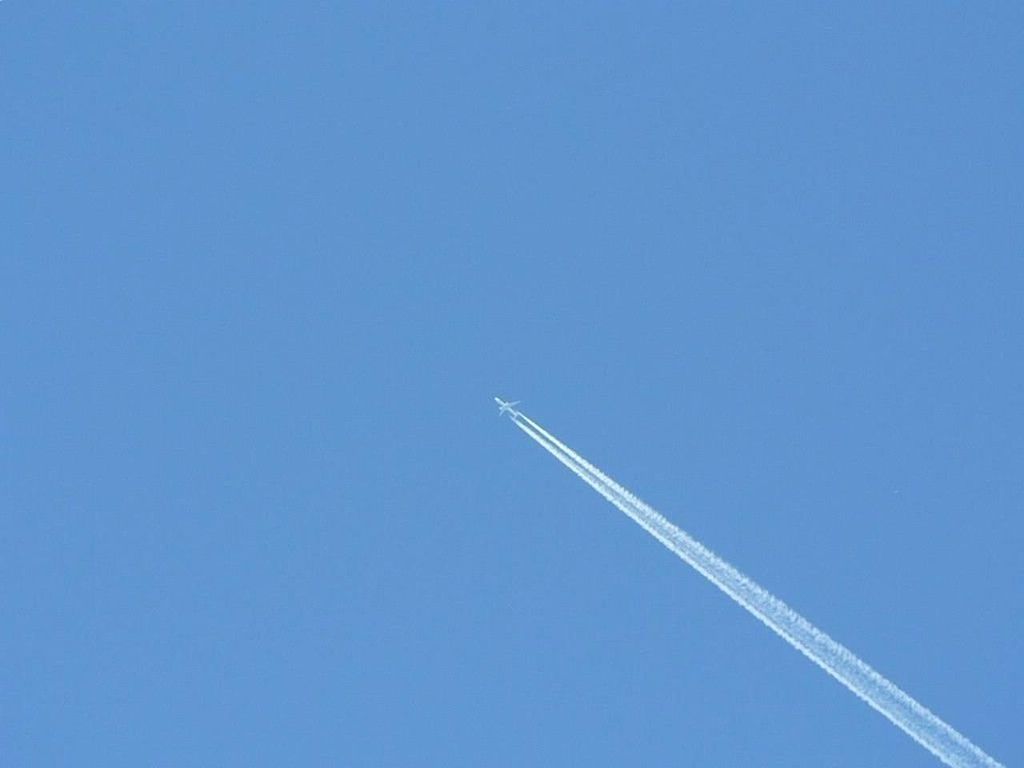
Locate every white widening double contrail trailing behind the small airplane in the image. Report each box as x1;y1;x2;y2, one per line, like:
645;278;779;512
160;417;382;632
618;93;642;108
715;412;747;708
506;410;1002;768
